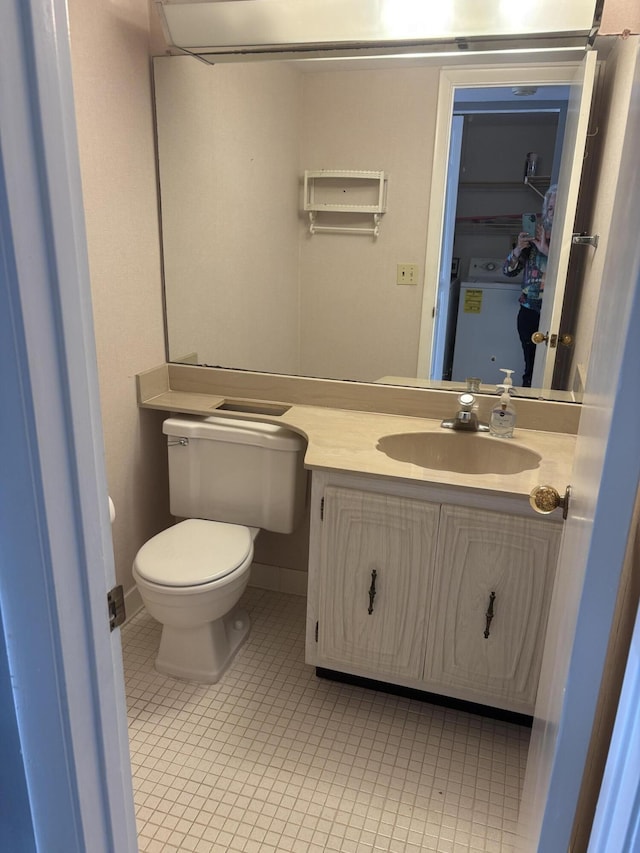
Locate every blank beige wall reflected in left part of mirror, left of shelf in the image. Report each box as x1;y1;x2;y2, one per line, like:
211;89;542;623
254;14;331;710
154;56;300;373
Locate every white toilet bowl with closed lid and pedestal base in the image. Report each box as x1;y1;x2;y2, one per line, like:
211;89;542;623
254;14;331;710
133;519;258;684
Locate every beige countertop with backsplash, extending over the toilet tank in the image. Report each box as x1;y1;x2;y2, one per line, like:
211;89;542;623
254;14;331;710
137;365;579;500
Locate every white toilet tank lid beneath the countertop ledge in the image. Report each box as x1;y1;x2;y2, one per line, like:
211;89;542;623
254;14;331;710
162;416;306;453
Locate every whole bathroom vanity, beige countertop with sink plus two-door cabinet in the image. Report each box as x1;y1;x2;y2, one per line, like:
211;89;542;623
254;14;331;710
138;365;577;716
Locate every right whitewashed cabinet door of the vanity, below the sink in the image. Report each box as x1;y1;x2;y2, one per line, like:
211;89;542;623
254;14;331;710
425;506;560;713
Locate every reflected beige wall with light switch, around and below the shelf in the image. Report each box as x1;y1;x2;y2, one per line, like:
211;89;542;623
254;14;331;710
300;67;440;381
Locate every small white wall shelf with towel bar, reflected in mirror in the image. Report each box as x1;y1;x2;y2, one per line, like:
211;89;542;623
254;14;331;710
304;169;388;237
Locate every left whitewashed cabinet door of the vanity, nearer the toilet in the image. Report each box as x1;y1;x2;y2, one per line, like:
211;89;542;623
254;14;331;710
318;486;439;678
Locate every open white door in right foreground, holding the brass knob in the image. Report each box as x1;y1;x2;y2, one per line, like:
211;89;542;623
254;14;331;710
518;45;640;853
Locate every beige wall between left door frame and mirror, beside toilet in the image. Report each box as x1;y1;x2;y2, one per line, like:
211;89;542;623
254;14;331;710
69;0;168;600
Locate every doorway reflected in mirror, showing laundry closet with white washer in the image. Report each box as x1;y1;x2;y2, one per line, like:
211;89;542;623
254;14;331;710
430;86;569;384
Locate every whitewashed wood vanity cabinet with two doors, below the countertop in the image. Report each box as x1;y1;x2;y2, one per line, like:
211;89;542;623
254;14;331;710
306;472;562;714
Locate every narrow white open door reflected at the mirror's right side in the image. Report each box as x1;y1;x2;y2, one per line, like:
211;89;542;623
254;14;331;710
531;52;596;388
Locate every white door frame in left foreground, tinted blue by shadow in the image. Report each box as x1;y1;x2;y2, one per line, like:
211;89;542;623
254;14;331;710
0;0;137;853
